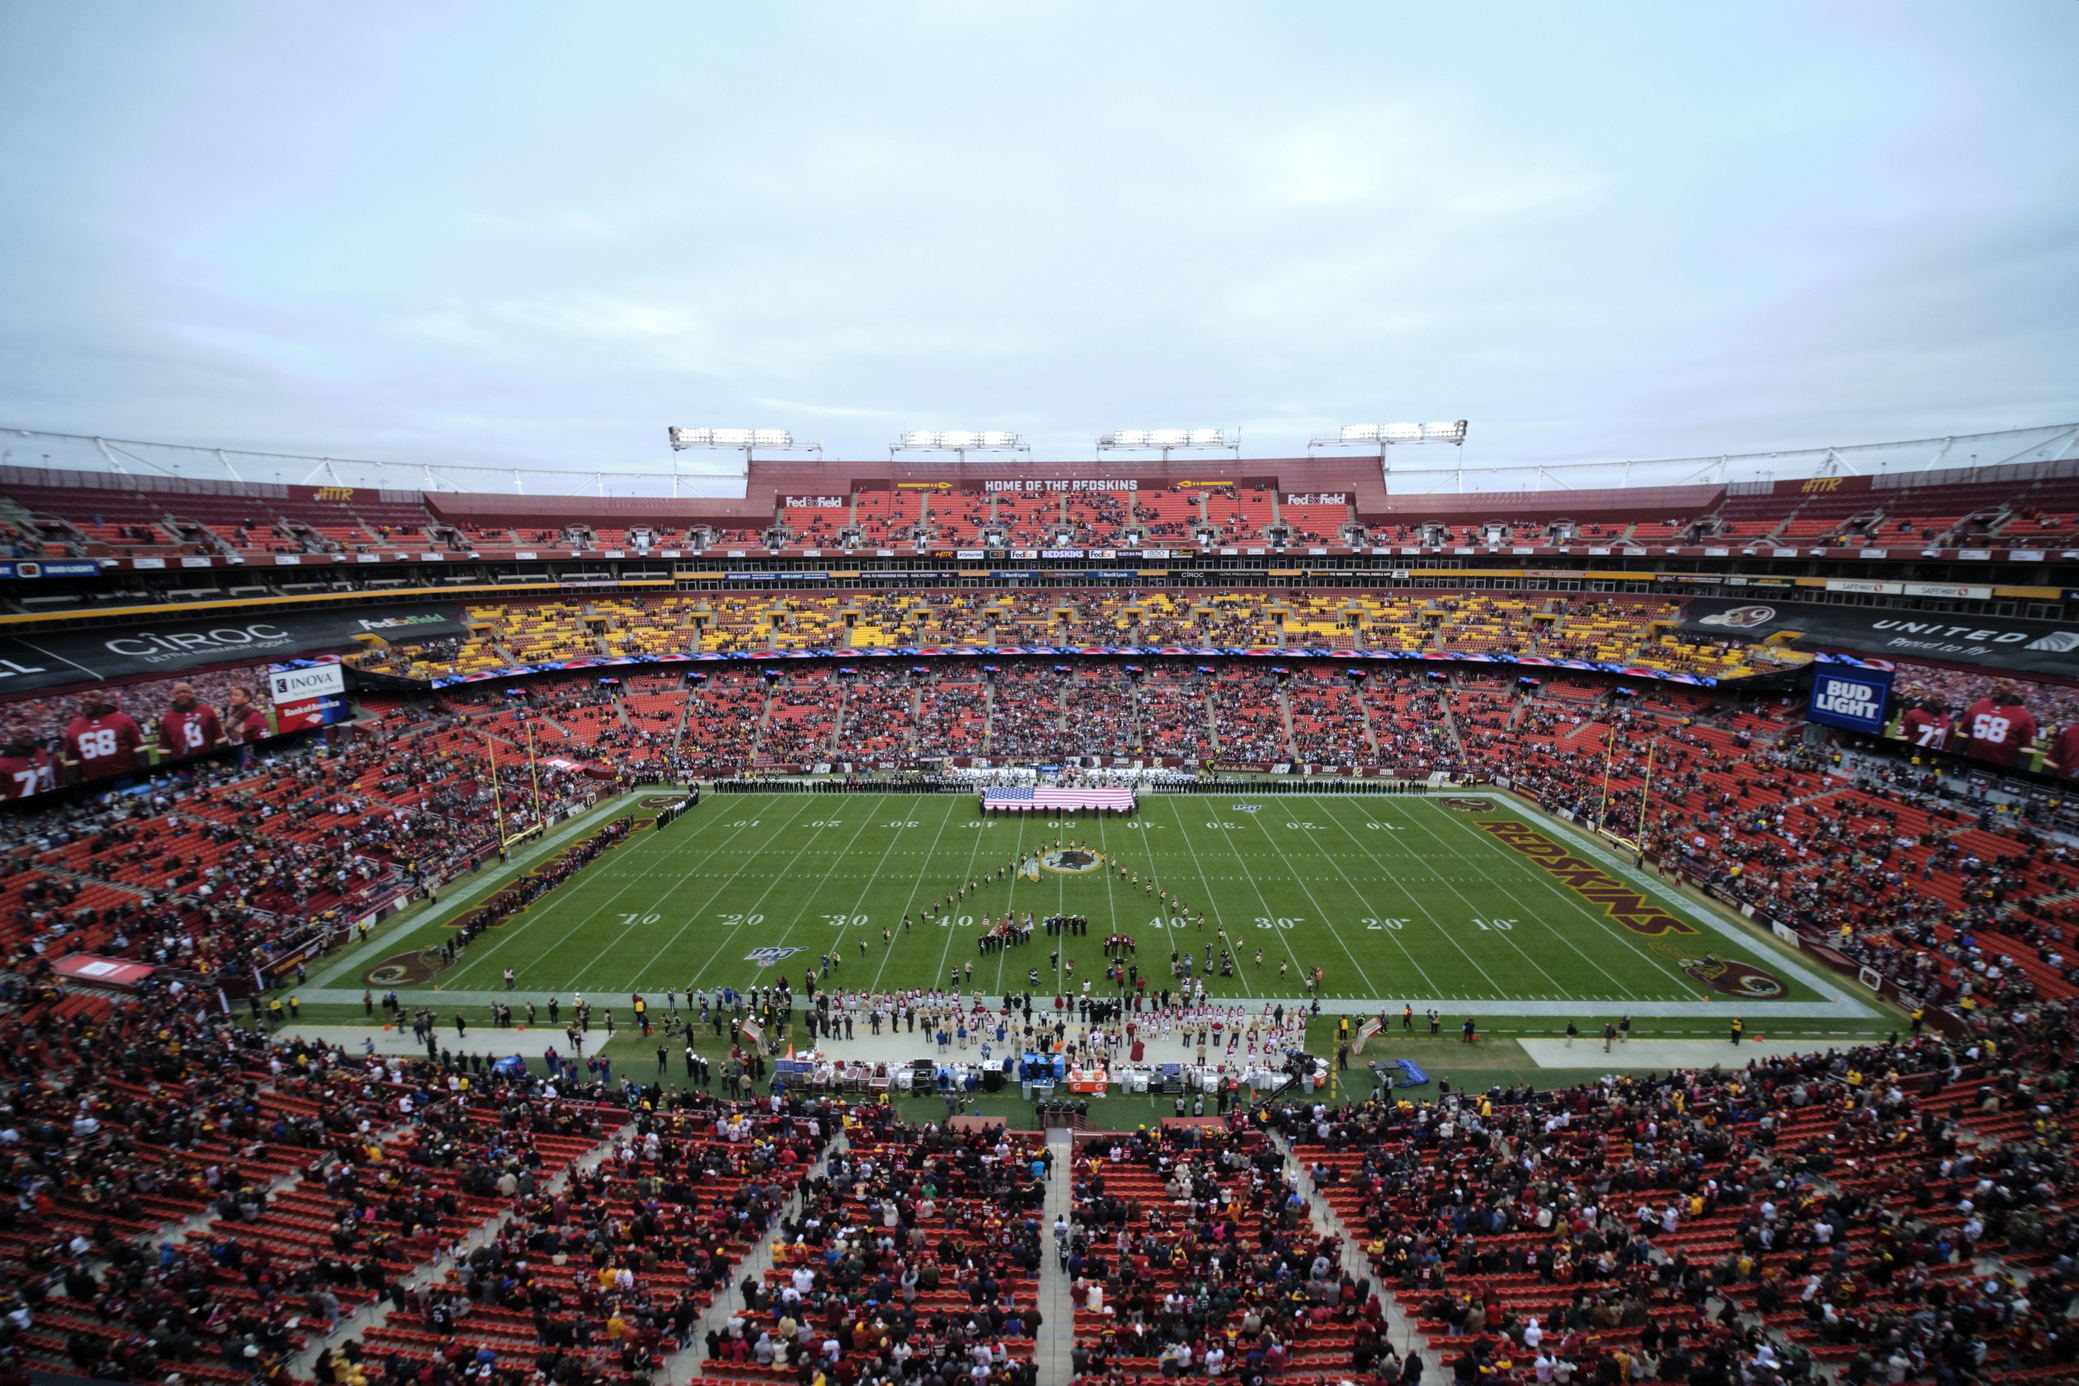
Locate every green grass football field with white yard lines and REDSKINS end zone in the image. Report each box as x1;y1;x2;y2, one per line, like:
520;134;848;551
326;794;1892;1035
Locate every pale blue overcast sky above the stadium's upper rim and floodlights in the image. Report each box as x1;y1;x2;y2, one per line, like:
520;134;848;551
0;0;2079;492
